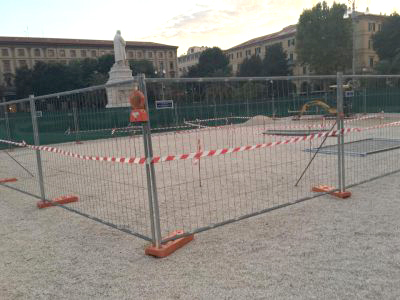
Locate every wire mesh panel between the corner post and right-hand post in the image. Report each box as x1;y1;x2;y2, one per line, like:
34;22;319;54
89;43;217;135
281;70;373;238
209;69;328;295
147;76;344;240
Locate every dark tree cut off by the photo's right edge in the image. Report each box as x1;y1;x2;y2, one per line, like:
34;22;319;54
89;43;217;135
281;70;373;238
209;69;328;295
372;13;400;74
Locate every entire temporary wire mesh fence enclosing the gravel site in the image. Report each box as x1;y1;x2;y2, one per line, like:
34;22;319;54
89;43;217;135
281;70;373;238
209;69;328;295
0;74;400;250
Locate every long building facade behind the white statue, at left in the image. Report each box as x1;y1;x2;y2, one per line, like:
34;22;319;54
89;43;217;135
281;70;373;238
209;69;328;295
0;37;178;97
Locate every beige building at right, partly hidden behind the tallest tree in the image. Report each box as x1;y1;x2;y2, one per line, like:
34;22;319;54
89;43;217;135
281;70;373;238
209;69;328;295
225;13;385;76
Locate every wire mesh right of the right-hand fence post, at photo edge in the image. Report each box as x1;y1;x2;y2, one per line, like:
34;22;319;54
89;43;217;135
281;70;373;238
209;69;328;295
344;76;400;186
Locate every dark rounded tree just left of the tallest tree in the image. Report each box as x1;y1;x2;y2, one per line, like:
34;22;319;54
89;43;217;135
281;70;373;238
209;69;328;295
263;44;290;76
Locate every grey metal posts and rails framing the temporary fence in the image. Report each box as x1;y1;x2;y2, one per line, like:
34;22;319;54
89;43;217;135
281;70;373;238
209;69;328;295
0;73;400;247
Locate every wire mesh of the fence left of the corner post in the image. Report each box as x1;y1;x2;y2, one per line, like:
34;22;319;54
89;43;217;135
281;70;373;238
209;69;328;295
1;80;151;239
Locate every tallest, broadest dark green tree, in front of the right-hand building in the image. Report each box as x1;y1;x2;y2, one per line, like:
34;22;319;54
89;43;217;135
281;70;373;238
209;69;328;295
296;1;352;74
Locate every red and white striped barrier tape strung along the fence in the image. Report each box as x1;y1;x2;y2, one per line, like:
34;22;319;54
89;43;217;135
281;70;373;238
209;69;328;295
0;122;400;164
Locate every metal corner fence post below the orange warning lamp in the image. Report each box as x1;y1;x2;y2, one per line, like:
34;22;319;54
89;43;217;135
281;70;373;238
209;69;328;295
139;74;161;248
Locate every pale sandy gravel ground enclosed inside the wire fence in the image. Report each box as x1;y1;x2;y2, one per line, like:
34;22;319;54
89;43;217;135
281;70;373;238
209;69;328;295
0;114;400;237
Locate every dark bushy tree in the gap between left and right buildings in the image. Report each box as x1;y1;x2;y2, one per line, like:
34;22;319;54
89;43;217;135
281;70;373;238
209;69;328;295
188;47;231;77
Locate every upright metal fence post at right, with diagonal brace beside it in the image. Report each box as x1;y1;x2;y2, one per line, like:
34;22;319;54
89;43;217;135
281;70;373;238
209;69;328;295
336;72;345;193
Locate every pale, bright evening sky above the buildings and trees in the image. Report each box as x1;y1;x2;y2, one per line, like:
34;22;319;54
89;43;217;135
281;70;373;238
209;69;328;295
0;0;400;55
